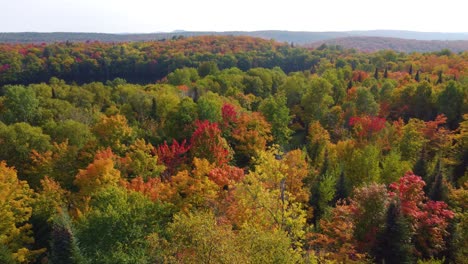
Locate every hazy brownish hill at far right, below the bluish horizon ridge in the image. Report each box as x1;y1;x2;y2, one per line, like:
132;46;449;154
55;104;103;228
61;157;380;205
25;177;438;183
307;37;468;52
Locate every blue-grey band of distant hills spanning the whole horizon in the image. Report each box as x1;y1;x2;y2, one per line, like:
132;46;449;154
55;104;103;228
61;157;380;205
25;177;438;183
0;30;468;52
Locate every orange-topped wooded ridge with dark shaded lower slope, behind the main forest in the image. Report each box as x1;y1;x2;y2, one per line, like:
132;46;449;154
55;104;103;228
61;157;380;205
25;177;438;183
0;36;320;85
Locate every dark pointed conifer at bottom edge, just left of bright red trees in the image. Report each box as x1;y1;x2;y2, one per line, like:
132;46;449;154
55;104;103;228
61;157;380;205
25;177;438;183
375;201;413;264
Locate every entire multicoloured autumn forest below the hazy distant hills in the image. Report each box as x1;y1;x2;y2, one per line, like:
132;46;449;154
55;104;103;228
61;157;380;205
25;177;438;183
0;37;468;263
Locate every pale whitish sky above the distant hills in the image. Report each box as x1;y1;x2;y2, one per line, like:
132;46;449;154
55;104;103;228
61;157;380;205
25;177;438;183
0;0;468;33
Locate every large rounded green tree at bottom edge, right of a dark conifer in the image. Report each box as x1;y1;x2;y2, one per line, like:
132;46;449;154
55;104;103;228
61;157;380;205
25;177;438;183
75;187;171;263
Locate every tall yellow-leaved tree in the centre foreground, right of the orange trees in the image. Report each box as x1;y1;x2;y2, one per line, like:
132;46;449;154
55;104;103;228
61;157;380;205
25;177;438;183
228;149;306;249
